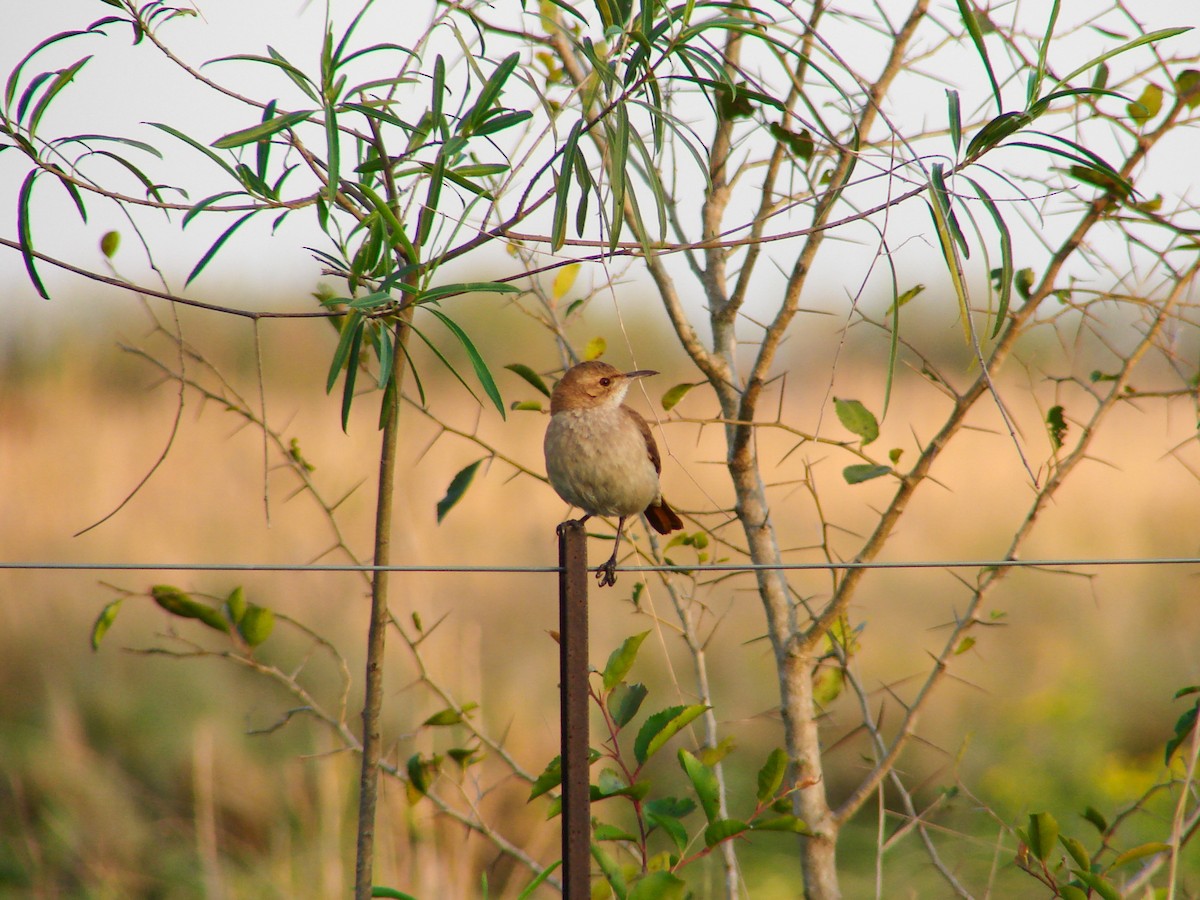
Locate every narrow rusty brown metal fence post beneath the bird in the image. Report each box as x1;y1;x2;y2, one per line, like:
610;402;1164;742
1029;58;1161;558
558;521;592;900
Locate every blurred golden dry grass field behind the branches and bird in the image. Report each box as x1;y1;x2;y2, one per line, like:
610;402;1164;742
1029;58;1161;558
0;294;1200;899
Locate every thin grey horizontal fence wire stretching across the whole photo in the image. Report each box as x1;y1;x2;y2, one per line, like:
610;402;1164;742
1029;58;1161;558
7;557;1200;575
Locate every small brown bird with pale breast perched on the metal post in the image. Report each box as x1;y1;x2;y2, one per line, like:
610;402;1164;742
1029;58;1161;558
545;360;683;587
